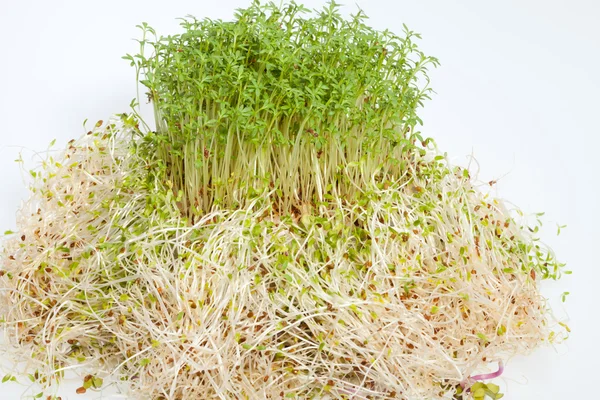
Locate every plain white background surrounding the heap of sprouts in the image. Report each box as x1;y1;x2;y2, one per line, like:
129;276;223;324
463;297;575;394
0;0;600;400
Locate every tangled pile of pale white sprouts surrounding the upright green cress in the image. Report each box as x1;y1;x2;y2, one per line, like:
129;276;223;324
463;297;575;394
0;118;560;400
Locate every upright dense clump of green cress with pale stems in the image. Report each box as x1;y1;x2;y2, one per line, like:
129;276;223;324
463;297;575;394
125;1;437;216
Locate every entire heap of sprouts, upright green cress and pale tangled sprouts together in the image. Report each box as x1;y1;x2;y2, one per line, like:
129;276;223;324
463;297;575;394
0;2;569;400
